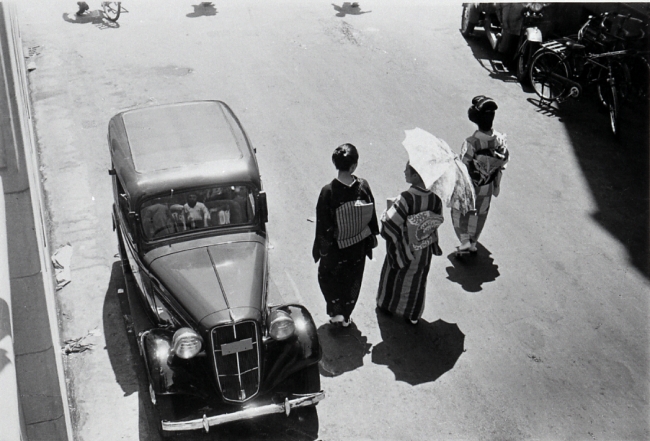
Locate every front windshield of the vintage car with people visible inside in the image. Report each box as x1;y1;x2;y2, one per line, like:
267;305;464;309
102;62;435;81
140;185;255;240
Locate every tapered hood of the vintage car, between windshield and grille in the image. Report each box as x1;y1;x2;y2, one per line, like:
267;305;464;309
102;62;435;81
150;241;266;329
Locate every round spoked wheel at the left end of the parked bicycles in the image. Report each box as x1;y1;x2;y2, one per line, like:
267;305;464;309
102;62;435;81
529;49;569;102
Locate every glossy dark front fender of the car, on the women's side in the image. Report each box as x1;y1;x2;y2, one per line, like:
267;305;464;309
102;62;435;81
263;305;322;390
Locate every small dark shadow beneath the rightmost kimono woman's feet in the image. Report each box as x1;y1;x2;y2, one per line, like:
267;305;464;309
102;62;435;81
446;243;501;292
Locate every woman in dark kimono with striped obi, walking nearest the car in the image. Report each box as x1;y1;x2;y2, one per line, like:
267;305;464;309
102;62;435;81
312;144;379;326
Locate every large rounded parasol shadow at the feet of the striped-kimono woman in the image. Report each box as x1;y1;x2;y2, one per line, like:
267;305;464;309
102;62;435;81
372;312;465;386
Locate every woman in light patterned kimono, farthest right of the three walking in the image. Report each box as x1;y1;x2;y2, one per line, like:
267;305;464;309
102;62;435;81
451;95;510;254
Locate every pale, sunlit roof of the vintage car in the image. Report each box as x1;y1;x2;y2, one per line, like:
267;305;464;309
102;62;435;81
108;101;260;205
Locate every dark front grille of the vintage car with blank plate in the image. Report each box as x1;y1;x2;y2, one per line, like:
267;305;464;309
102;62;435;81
212;321;260;402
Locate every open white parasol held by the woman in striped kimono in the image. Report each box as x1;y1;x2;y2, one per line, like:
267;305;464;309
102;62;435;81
402;127;476;214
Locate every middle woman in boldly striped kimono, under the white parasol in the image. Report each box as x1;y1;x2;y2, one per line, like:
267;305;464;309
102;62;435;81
377;163;442;325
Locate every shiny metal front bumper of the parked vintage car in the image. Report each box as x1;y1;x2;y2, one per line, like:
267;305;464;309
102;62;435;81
161;391;325;432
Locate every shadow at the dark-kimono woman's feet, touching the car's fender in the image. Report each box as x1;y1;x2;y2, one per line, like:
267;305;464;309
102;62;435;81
318;323;372;377
